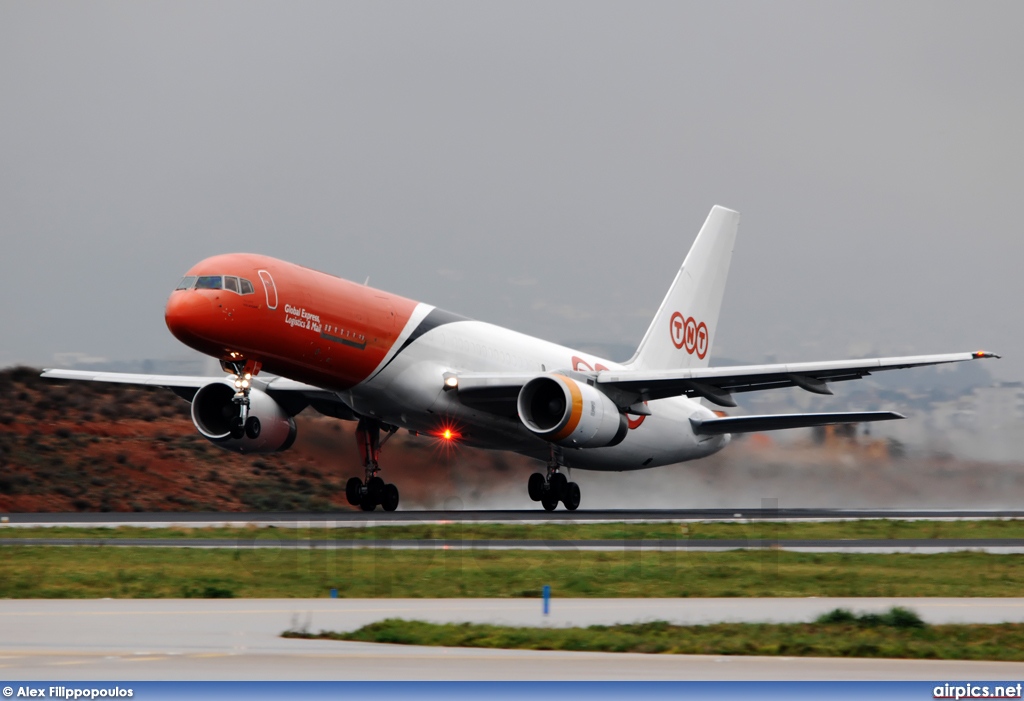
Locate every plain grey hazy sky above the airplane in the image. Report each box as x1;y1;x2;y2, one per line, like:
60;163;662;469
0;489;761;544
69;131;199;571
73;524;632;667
0;0;1024;380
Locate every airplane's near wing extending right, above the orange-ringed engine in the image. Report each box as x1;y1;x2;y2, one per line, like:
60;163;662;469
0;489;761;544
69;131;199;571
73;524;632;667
597;351;999;406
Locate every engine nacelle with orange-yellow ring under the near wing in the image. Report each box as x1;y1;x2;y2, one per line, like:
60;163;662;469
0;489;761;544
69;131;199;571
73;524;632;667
517;374;629;448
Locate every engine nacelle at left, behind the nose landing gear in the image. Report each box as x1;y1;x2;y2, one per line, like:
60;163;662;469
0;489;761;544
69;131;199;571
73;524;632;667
191;381;296;452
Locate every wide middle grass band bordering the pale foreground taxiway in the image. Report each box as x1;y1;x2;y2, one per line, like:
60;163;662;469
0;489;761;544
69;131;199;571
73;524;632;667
0;545;1024;599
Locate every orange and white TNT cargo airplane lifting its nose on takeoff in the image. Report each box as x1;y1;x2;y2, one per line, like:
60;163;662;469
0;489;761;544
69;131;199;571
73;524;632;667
42;206;999;511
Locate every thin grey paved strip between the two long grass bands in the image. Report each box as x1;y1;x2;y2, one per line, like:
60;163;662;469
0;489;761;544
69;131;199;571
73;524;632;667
0;534;1024;555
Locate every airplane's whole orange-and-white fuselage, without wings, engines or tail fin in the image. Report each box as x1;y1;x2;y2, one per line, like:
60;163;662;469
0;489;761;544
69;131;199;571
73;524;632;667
165;254;728;471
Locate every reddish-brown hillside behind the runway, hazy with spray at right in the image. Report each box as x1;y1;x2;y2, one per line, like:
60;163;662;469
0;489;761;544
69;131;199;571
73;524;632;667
0;368;1024;512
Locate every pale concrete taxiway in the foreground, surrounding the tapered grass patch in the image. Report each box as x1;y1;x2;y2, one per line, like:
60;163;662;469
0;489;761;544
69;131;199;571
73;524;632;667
6;598;1024;682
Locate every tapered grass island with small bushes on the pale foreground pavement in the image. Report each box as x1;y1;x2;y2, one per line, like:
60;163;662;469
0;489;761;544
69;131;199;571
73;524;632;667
285;612;1024;661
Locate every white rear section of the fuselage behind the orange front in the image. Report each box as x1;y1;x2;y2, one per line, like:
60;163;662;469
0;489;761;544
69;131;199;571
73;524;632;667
341;305;729;471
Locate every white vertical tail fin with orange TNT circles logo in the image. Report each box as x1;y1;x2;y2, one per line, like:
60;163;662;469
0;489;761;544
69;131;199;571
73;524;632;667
628;205;739;370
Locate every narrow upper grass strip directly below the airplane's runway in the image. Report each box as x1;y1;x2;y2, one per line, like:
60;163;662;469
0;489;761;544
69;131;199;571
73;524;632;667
6;514;1024;540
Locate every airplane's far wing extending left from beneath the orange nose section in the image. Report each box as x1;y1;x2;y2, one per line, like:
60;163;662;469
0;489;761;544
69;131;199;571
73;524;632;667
41;369;357;420
